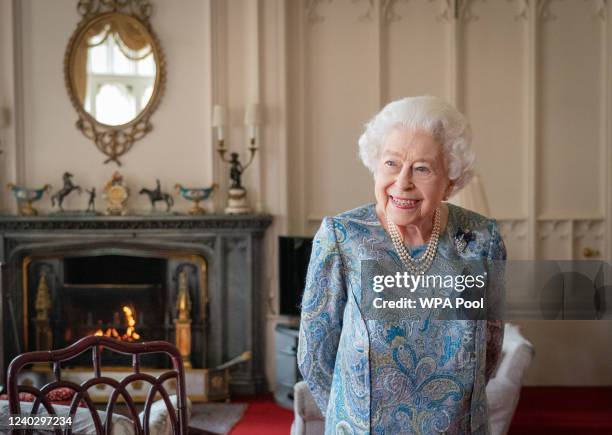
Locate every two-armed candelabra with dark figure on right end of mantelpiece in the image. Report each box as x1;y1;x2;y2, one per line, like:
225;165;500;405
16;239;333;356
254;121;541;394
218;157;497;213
212;103;261;214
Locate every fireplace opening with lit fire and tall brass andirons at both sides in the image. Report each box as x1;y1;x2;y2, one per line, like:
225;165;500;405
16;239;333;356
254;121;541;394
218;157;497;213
22;252;206;368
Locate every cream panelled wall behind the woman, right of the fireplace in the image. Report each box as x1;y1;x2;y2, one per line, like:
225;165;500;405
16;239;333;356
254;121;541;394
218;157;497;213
287;0;612;385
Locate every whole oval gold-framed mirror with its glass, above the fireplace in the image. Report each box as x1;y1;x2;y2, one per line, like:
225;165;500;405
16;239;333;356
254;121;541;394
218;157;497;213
64;0;166;165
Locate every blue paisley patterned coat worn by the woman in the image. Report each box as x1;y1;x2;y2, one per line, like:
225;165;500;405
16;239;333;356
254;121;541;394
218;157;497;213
298;204;506;435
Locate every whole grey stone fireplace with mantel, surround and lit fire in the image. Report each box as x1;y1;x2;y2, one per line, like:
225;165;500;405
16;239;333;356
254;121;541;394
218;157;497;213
0;215;271;394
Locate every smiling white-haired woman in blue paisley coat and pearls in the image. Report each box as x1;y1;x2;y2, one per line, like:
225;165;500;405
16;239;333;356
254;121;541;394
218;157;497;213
298;96;506;435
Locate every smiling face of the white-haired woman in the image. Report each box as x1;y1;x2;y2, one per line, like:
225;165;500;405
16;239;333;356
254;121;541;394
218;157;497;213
374;128;451;231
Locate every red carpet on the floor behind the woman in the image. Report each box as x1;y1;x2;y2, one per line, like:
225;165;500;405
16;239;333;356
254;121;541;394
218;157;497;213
230;387;612;435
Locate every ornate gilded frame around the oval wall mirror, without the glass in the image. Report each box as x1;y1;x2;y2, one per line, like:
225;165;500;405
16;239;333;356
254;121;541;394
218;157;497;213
64;0;166;166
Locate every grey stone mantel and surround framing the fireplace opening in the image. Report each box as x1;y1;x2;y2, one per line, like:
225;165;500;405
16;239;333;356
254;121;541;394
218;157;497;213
0;215;272;394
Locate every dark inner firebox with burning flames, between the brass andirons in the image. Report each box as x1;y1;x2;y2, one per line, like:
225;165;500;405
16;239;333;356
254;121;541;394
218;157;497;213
62;255;163;348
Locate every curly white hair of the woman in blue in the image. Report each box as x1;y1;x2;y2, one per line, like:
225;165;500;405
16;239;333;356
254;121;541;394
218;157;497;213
359;96;475;195
